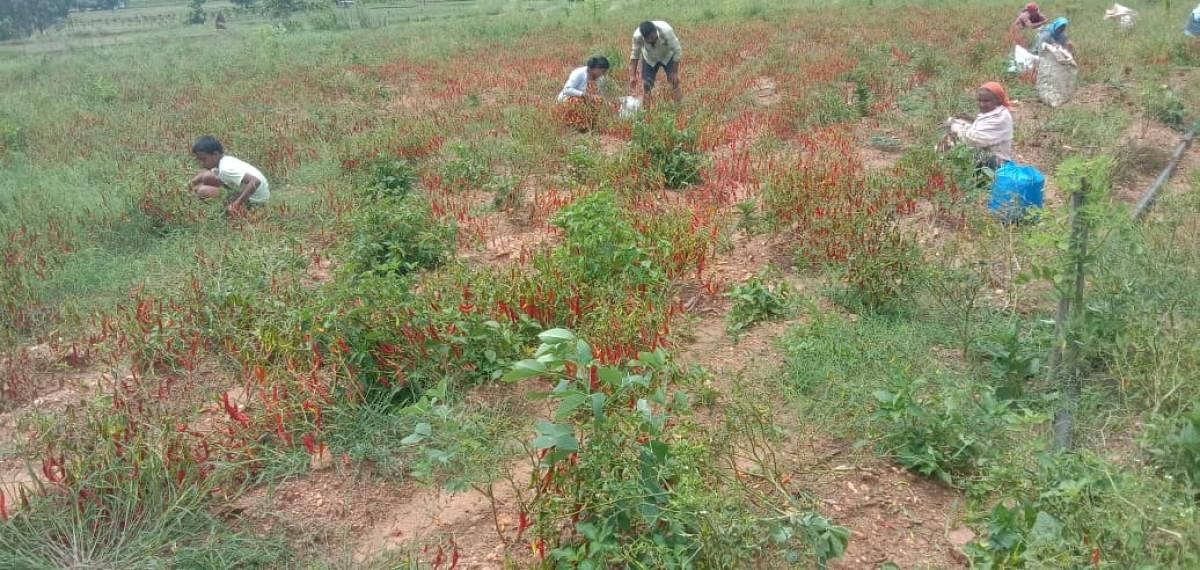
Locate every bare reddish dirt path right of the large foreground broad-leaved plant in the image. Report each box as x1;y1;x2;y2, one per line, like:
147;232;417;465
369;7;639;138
678;230;974;569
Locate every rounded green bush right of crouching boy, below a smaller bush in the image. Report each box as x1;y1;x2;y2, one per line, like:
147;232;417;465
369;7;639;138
349;196;455;275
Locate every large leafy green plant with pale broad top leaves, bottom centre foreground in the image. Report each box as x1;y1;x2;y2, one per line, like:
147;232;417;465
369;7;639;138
504;329;848;569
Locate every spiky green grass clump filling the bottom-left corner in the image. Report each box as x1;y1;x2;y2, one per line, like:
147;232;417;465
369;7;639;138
0;451;289;568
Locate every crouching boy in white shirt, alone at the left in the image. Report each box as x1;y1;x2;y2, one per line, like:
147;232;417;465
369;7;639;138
187;137;271;216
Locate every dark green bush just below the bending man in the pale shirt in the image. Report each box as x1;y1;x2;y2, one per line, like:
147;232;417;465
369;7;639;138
632;113;704;188
